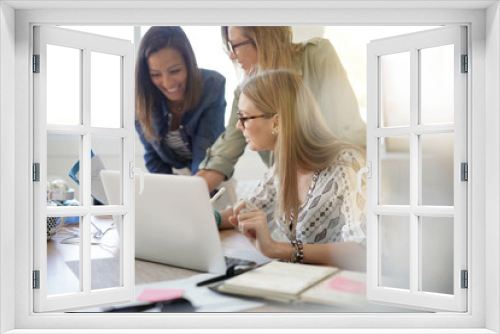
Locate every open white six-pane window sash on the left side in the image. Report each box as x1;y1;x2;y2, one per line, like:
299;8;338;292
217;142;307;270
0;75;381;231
33;26;135;312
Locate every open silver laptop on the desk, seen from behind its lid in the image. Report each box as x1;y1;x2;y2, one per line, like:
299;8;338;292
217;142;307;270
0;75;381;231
101;170;265;275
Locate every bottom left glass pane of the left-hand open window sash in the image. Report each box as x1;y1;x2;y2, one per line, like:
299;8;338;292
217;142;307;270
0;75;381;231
47;217;82;296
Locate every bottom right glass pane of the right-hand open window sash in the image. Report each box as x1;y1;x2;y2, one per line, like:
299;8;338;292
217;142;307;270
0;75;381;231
421;217;453;294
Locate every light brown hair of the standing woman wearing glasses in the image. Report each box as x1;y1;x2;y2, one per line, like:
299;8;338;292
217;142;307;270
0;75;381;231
221;26;302;74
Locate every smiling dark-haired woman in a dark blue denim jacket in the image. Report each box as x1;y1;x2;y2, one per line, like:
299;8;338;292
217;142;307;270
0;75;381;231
135;27;226;174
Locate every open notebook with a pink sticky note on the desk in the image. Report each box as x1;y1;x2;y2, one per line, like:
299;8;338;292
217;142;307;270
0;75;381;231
212;261;367;308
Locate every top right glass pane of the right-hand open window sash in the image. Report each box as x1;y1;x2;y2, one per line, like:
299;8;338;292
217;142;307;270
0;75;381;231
420;45;455;124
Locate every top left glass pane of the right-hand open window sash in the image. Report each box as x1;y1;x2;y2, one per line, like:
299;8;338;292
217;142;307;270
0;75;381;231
380;52;410;127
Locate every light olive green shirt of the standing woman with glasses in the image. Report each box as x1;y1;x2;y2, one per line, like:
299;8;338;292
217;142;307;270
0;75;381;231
200;38;366;178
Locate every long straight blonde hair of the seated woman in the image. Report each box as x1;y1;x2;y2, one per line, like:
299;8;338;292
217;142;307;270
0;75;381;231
242;70;354;226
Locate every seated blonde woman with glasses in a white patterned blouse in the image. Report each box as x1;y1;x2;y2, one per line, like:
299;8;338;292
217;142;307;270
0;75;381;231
216;70;366;270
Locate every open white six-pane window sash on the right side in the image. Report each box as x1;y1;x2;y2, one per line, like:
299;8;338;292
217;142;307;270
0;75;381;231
366;26;470;312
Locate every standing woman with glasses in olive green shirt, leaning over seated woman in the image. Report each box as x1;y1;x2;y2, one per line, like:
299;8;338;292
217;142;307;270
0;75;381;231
197;27;366;190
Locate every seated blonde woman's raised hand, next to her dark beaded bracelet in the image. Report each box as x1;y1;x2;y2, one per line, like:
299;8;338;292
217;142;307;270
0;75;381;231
229;201;277;257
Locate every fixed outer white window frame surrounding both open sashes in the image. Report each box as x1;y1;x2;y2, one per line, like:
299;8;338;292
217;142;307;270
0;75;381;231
0;1;500;333
